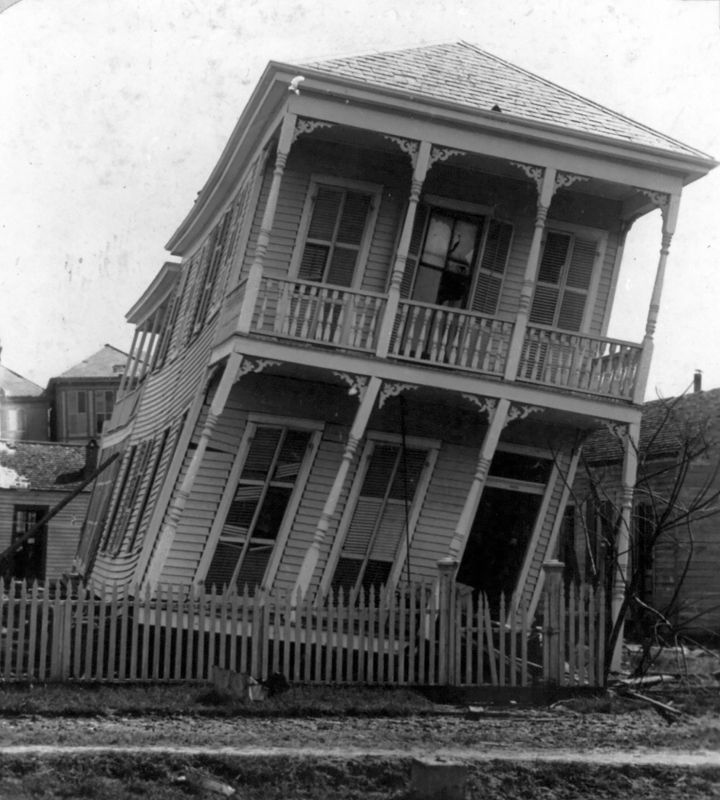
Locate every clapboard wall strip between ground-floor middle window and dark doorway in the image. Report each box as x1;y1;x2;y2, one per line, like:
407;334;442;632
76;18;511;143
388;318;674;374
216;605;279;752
403;443;478;580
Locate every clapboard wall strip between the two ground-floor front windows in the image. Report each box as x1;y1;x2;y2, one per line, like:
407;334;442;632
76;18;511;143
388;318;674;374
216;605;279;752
275;425;359;589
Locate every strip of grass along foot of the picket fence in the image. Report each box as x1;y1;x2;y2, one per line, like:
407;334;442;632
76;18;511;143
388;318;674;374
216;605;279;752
0;684;433;717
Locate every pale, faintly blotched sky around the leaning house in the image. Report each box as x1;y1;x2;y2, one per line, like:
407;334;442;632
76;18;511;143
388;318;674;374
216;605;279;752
0;0;720;399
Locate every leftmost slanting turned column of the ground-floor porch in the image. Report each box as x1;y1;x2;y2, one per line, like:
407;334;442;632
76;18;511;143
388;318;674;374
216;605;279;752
145;351;243;586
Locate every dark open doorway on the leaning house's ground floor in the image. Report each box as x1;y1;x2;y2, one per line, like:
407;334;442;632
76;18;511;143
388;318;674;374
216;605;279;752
457;486;542;605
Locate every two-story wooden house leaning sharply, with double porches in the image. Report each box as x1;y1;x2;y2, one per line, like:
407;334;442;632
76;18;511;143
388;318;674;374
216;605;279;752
76;43;716;648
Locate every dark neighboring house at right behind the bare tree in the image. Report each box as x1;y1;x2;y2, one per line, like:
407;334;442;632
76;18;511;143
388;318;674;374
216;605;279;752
558;382;720;636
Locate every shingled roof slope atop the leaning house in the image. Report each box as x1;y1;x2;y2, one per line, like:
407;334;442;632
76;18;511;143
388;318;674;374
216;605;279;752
302;41;710;159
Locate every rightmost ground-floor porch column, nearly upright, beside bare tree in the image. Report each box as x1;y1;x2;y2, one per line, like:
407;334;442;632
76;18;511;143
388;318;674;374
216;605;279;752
610;422;640;672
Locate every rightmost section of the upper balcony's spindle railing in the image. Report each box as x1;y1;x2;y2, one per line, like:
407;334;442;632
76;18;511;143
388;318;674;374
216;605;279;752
517;326;642;400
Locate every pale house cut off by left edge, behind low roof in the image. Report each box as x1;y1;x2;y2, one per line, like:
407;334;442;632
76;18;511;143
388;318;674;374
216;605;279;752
0;358;48;442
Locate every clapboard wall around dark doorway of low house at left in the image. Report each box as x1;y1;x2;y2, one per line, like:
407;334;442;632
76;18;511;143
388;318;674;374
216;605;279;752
0;489;90;580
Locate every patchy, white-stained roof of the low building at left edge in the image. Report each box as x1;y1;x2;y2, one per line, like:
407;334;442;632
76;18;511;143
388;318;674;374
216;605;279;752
0;441;90;492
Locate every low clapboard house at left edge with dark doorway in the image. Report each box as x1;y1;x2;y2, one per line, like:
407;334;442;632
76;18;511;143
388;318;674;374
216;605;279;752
0;441;97;582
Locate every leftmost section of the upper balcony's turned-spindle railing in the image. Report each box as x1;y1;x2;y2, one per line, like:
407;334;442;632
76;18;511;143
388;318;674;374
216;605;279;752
251;278;386;352
